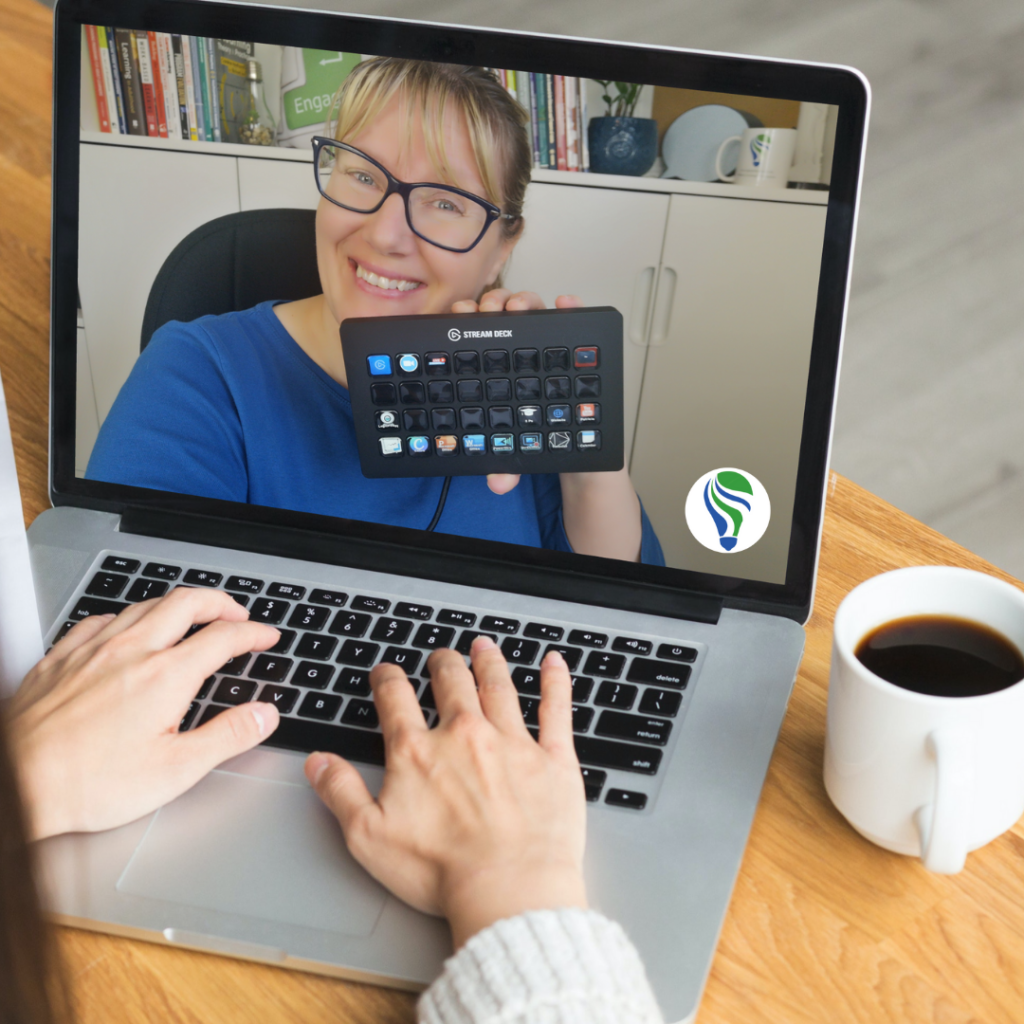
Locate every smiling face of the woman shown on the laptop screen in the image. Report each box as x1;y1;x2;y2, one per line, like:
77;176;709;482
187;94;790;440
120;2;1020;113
316;93;515;323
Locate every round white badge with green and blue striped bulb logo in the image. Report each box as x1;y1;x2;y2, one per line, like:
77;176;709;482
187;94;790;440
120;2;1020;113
686;467;771;554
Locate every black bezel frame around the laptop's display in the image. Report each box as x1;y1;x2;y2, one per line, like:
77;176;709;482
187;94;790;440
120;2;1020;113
50;0;869;622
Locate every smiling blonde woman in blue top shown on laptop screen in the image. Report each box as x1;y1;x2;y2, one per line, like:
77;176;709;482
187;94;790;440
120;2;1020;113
86;57;664;564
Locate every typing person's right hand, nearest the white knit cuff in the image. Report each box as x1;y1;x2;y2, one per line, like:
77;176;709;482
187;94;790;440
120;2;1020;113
306;637;587;948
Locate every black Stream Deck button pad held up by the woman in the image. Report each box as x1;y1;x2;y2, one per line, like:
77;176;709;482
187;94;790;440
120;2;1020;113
341;306;624;478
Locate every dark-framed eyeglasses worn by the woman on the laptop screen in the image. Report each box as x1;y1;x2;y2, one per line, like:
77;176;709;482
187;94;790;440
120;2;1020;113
313;135;517;253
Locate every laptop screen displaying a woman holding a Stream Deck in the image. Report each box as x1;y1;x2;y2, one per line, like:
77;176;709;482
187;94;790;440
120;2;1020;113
51;4;859;614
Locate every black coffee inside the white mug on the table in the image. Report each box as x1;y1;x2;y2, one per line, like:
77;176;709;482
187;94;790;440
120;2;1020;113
855;615;1024;697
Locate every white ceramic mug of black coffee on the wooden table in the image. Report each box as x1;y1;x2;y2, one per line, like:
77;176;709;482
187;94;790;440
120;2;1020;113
824;565;1024;874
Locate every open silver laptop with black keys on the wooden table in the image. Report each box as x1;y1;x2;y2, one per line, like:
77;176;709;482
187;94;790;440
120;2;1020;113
29;0;868;1021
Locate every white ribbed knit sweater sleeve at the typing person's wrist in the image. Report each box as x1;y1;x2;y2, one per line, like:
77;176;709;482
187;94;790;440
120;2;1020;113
418;908;663;1024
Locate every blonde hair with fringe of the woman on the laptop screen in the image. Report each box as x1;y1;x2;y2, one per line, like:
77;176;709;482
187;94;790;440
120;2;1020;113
329;57;532;239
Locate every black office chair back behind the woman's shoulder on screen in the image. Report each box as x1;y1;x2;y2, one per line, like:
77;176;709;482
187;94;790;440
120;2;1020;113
139;210;322;351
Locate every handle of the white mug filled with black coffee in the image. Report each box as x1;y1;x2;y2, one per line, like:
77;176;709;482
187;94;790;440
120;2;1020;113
914;729;974;874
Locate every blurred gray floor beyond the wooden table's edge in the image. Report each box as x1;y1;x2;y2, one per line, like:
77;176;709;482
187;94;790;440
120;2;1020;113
56;0;1024;578
